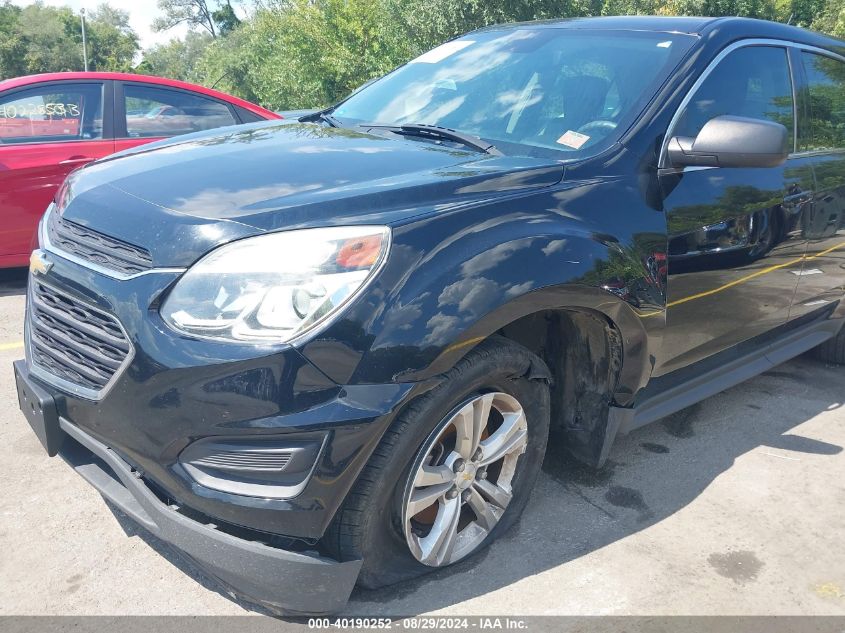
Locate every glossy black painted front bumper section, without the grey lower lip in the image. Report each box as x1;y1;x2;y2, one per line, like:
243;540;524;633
21;252;414;544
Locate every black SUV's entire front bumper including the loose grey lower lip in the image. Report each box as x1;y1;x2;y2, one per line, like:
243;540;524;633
16;246;414;614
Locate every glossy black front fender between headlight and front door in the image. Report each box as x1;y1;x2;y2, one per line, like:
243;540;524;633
302;180;665;394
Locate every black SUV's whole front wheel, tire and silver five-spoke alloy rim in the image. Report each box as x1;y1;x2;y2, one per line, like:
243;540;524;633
324;339;549;588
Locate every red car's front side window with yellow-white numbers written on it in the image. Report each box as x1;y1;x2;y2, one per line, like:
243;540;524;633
0;84;103;145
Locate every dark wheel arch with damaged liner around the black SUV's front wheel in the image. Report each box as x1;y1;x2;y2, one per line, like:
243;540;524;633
408;286;652;467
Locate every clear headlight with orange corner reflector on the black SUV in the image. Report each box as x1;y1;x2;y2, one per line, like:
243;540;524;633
161;226;390;343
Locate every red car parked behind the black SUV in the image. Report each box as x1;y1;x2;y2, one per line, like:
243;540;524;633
0;72;280;268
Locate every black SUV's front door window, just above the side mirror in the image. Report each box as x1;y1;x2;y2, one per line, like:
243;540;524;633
672;46;795;143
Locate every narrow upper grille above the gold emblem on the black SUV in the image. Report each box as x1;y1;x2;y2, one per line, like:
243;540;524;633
47;212;153;275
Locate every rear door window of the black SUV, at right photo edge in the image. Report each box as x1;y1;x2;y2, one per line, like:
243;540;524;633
801;52;845;150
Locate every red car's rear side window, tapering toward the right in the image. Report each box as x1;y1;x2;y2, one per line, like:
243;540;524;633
123;84;237;138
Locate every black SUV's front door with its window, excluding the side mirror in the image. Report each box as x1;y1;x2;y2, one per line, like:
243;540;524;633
654;45;814;376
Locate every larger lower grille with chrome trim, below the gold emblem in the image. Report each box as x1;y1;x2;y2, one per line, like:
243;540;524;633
29;278;132;391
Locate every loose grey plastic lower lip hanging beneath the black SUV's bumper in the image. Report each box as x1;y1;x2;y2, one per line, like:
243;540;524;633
49;388;361;615
